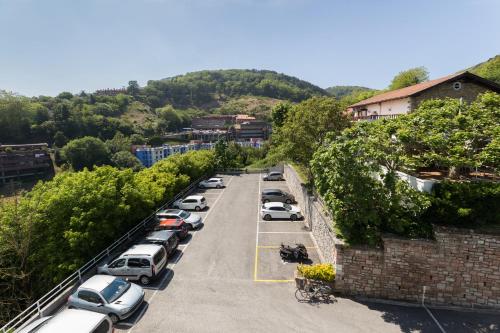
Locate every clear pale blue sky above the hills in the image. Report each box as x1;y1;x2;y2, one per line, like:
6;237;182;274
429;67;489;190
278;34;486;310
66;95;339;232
0;0;500;96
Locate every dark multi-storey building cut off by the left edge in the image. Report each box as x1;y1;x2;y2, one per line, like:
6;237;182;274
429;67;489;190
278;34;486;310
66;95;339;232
0;143;54;183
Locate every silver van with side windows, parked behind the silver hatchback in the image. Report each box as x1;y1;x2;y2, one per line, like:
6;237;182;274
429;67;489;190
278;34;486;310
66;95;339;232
97;244;167;285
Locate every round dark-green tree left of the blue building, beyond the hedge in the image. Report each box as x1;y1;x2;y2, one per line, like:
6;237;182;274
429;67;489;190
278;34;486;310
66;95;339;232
61;136;110;171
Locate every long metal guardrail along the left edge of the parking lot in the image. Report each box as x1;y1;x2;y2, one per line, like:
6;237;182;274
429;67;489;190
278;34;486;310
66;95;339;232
0;175;209;333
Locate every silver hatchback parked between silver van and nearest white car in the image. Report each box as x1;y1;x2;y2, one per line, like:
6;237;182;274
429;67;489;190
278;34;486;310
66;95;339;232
68;275;144;323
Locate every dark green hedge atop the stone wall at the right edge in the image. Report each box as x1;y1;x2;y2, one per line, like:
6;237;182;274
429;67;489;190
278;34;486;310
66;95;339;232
422;181;500;228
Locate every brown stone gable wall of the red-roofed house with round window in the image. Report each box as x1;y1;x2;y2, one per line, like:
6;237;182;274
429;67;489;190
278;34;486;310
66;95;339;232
410;79;489;110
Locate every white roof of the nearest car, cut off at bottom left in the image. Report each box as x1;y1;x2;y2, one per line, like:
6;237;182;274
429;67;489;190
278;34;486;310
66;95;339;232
21;309;107;333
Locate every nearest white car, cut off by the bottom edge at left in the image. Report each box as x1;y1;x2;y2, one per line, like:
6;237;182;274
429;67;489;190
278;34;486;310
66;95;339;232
16;309;113;333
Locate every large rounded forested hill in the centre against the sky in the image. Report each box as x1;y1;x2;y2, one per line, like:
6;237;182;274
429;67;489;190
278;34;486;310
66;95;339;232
141;69;327;108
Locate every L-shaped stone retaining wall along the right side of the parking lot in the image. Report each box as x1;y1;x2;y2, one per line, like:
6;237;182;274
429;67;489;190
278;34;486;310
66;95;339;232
285;166;500;309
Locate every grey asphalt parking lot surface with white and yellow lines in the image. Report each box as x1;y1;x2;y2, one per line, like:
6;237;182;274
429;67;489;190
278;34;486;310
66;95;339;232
116;174;500;332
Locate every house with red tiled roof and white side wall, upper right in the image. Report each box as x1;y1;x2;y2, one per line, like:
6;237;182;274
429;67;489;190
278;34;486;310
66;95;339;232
348;72;500;120
